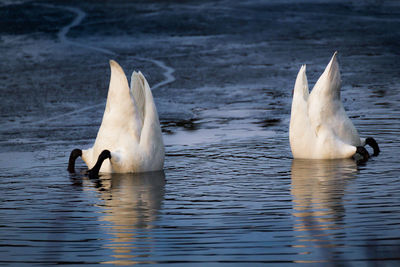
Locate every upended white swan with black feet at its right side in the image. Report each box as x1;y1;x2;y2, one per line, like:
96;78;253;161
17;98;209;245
289;52;379;160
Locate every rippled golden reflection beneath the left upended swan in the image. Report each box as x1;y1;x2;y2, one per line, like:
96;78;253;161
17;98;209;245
96;171;165;265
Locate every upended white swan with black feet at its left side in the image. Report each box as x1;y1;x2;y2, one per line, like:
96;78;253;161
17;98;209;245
68;60;165;176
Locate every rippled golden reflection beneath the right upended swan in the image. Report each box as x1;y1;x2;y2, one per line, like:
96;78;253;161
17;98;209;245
291;159;357;260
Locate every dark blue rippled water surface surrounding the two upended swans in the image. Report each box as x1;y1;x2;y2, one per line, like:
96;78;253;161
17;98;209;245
0;1;400;266
